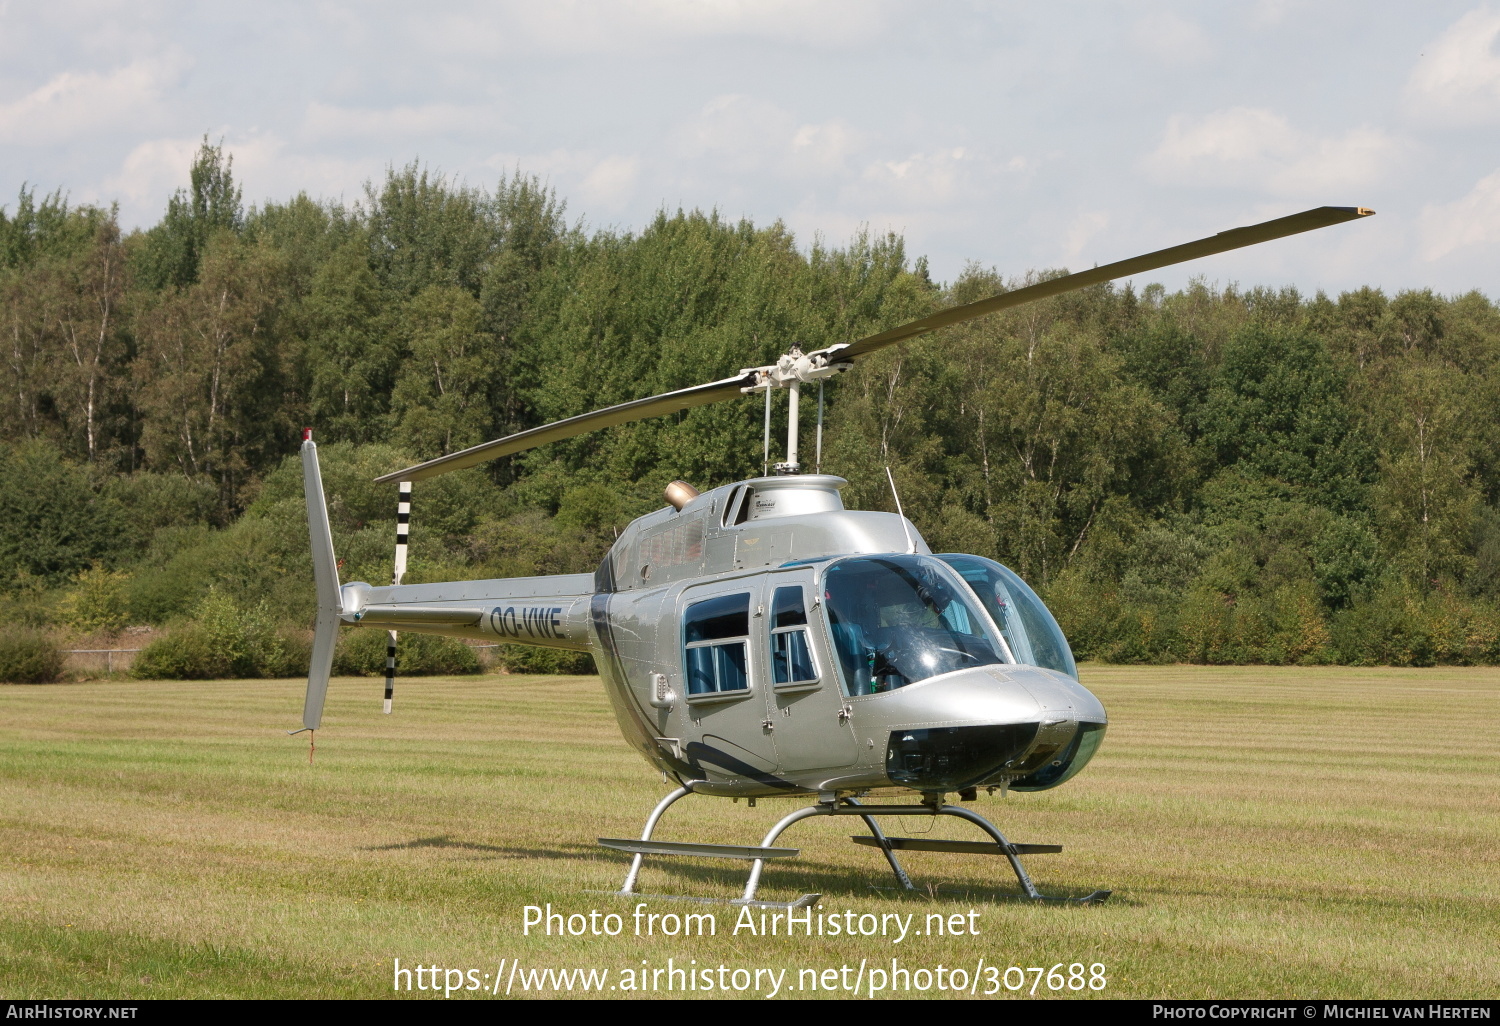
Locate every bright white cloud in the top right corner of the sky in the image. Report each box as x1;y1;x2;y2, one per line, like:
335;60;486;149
1404;8;1500;125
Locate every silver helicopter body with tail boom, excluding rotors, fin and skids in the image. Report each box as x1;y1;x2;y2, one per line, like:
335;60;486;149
344;476;1107;797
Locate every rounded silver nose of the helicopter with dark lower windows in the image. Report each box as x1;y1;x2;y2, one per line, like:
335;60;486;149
861;666;1106;791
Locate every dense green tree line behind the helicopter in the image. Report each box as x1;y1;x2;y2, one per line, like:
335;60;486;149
0;141;1500;665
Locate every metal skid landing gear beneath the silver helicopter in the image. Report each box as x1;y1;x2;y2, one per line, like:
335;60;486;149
599;788;1110;909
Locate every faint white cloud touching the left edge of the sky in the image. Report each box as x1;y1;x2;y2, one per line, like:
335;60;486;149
0;59;182;146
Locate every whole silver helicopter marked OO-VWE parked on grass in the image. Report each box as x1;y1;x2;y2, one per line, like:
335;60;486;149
291;207;1374;909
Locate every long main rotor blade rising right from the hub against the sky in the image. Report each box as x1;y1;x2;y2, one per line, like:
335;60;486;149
822;207;1376;360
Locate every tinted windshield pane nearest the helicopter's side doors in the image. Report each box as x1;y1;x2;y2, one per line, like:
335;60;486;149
824;555;1005;695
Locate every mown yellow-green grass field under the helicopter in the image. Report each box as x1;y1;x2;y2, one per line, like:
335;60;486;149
0;666;1500;999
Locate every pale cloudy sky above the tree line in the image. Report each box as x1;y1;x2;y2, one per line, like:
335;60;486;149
0;0;1500;299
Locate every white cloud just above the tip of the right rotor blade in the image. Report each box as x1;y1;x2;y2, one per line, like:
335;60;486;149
1143;107;1407;204
